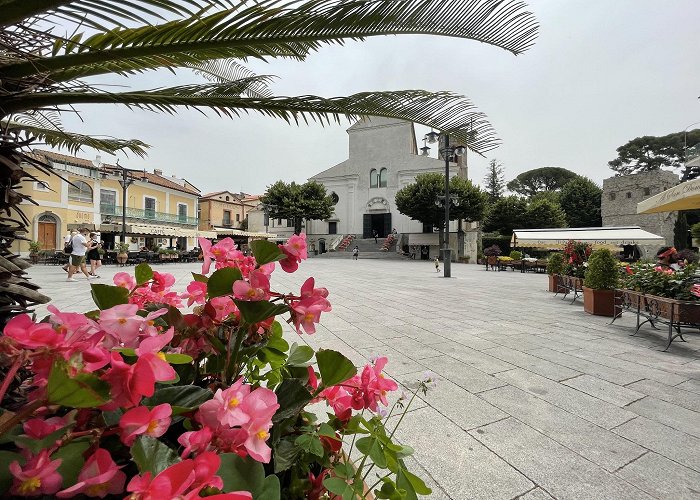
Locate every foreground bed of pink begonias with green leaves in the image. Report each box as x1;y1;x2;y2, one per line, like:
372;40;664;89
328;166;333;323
0;234;430;500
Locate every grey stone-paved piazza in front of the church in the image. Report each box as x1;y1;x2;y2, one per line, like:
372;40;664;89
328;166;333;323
26;259;700;500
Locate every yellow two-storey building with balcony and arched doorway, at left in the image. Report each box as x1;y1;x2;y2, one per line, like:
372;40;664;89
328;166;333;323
14;150;205;254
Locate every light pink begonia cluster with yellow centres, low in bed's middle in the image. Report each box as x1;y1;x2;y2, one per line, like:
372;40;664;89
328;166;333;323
178;378;279;463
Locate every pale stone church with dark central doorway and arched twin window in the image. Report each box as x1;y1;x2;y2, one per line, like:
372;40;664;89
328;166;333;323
306;117;477;261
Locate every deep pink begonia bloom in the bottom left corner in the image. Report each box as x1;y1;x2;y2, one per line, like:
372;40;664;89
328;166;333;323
9;450;63;497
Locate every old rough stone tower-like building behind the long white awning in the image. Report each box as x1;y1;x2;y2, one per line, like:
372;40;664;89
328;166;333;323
600;170;680;257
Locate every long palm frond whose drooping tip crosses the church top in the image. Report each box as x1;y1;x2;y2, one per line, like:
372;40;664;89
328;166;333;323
2;84;499;154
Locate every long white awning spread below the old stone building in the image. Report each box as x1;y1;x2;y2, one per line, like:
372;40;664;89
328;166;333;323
510;226;666;250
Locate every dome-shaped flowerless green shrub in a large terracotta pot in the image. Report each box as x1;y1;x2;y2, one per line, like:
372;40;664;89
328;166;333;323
583;248;620;316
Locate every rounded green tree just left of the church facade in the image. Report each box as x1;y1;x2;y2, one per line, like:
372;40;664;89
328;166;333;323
260;181;333;234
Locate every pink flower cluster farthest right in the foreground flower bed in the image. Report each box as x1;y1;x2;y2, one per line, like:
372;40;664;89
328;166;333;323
309;356;399;420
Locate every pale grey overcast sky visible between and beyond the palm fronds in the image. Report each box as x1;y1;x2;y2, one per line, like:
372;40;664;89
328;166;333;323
57;0;700;193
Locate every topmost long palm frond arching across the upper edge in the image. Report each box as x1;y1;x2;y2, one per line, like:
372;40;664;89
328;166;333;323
0;0;538;81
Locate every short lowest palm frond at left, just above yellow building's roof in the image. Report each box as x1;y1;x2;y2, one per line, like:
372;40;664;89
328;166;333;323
0;117;149;158
